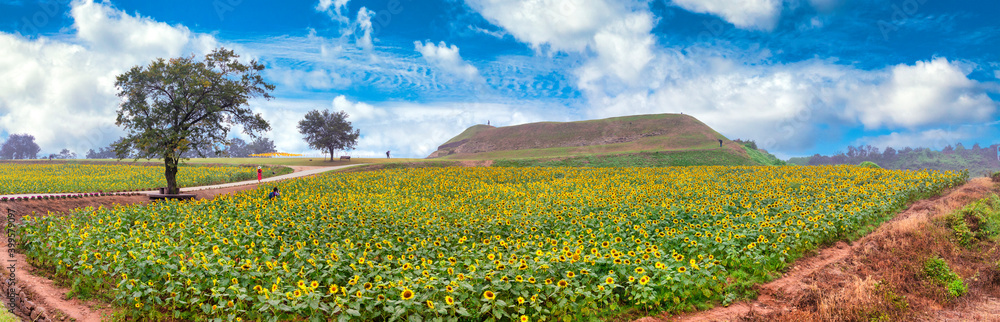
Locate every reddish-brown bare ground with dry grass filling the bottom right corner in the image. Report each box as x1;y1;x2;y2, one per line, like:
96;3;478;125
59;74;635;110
664;178;1000;322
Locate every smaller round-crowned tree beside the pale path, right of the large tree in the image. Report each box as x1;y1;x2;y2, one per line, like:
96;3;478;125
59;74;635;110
299;110;361;161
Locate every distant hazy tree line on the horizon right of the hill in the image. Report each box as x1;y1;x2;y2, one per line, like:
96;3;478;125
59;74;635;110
789;143;1000;175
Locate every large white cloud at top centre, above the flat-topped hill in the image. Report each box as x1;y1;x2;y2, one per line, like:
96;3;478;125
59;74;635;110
466;0;655;87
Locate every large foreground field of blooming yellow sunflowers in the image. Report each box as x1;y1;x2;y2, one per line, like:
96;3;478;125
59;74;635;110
18;166;967;321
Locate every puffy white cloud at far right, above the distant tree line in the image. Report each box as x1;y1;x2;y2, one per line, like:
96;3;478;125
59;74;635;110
847;58;997;129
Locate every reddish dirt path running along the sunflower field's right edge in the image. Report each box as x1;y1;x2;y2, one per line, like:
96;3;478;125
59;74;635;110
638;178;1000;322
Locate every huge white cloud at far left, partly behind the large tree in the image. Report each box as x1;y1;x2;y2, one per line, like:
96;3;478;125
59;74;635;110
0;1;217;154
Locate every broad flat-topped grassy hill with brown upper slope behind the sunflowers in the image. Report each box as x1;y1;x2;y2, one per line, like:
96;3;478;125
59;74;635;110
428;114;782;166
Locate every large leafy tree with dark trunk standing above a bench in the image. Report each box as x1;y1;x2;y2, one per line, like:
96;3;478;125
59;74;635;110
114;48;274;193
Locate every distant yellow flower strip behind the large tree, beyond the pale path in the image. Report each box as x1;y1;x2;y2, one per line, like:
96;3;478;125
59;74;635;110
0;163;291;195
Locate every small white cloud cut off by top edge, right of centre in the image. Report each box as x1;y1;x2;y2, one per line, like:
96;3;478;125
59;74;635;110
673;0;784;30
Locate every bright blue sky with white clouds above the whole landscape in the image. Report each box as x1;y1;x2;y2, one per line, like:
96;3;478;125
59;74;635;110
0;0;1000;157
